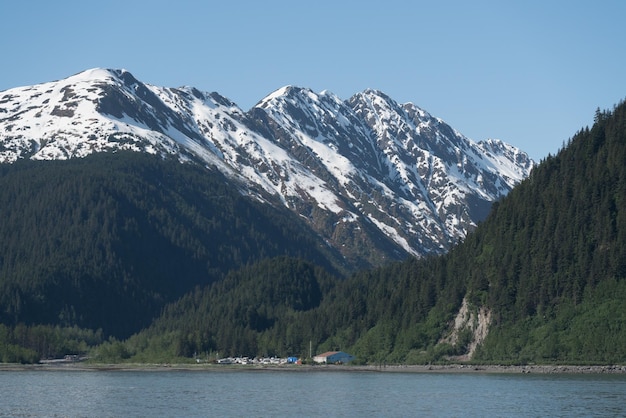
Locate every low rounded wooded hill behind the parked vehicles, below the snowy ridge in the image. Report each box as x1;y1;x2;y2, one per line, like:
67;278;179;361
122;258;336;359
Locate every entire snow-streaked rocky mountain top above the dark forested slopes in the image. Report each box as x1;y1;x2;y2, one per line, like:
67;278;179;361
0;69;534;264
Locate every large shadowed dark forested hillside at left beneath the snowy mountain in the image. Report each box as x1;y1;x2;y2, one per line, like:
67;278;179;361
0;152;342;338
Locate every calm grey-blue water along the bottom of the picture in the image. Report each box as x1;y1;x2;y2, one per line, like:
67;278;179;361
0;371;626;417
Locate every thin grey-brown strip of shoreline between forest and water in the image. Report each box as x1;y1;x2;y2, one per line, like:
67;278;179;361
0;362;626;374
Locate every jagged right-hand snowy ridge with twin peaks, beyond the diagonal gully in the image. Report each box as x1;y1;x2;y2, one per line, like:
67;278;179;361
256;87;534;255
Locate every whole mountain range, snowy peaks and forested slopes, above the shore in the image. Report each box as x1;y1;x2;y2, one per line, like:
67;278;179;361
0;70;626;365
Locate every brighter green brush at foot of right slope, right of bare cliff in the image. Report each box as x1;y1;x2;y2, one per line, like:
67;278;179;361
477;279;626;364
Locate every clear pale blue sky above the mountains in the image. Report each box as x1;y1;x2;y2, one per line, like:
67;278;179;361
0;0;626;160
